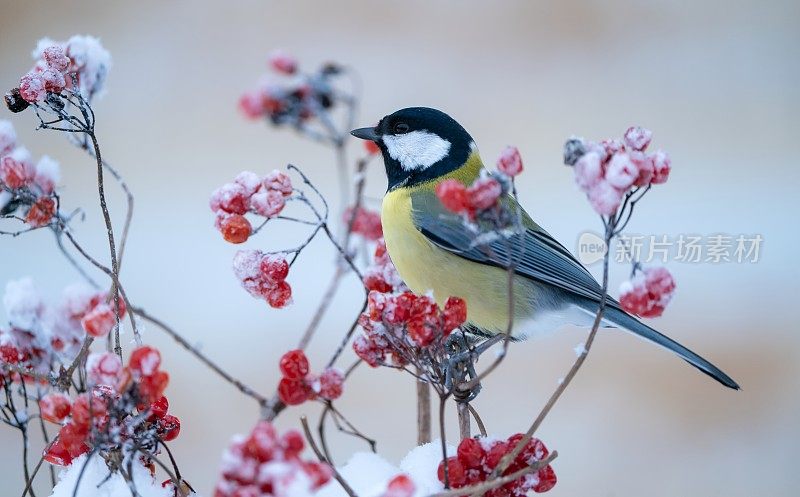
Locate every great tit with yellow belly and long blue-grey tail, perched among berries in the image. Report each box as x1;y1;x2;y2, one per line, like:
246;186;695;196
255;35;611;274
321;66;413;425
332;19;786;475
351;107;739;390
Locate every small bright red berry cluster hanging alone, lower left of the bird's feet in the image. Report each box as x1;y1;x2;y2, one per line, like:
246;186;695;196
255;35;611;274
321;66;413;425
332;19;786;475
278;349;344;406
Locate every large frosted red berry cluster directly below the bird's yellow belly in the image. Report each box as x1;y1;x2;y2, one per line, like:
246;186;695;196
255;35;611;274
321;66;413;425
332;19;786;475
353;290;467;367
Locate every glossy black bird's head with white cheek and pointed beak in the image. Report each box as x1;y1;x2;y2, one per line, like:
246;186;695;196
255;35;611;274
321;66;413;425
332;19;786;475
351;107;475;190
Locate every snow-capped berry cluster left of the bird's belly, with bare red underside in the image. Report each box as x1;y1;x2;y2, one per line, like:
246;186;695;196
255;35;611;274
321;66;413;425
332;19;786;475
233;250;292;309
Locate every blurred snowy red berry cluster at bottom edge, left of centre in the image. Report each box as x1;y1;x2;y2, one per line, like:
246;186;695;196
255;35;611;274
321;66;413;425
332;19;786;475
214;421;332;497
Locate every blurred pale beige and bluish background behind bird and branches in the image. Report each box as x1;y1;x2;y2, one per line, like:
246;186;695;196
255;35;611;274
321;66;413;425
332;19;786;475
0;0;800;497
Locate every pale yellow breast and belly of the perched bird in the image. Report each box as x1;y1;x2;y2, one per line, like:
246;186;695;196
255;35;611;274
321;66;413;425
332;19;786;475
381;176;534;334
